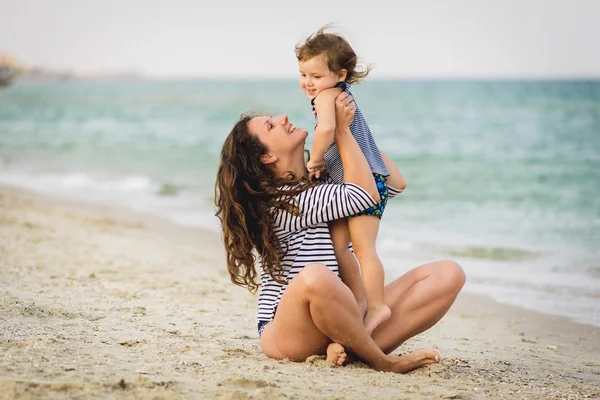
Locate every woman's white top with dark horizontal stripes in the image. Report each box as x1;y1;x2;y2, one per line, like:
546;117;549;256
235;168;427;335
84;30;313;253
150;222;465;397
258;183;400;322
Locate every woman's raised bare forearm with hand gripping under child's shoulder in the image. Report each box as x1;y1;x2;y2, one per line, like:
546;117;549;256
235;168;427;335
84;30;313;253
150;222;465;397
334;92;379;201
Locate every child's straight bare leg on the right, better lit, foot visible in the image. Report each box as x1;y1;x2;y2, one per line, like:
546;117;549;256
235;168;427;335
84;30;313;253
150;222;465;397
348;215;392;333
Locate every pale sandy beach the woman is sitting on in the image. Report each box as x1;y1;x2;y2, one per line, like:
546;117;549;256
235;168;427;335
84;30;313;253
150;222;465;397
0;187;600;399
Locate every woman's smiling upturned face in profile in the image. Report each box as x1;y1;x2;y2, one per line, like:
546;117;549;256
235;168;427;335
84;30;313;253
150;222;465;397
248;115;308;159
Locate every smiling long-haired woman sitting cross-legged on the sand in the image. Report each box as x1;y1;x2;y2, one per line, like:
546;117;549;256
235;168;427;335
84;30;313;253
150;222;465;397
215;93;465;373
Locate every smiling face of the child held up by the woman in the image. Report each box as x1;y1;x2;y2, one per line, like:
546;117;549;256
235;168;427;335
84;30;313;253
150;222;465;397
298;54;346;100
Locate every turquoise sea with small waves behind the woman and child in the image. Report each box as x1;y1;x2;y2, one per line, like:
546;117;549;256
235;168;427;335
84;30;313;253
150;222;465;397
0;81;600;325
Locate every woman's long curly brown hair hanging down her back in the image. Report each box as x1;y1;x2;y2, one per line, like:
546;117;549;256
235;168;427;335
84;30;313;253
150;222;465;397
215;115;312;293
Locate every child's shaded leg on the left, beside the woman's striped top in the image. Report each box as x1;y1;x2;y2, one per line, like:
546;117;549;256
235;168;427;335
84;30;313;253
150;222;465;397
329;219;367;316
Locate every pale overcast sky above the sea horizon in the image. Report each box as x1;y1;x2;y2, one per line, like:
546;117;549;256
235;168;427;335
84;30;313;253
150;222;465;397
0;0;600;78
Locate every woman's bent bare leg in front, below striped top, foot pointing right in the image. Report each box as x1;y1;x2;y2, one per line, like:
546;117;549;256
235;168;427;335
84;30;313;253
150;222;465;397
260;264;439;373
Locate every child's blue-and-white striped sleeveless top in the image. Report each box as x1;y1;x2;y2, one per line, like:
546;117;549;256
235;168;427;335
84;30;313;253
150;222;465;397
312;82;390;184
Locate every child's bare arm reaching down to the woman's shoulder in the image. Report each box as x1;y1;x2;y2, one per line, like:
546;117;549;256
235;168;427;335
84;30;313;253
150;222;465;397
307;88;342;178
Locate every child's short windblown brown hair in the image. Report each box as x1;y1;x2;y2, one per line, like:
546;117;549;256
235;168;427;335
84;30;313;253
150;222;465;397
296;24;371;84
